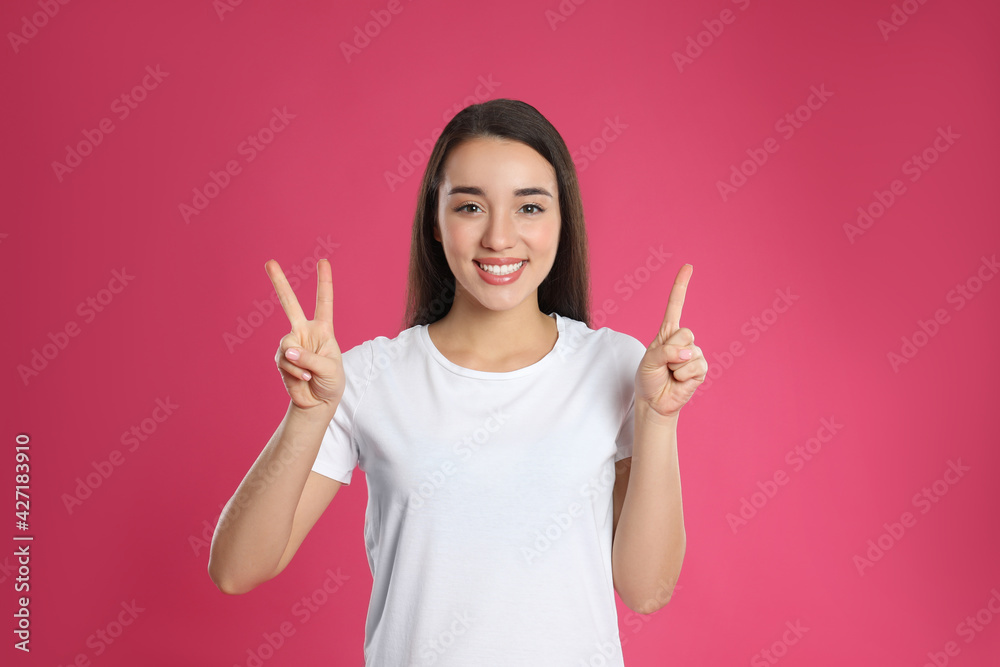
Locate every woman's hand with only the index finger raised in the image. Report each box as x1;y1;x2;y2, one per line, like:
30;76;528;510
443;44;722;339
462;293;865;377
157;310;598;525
635;264;708;417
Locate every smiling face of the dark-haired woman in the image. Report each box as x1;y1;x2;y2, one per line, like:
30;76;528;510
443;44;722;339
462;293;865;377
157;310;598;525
434;137;560;318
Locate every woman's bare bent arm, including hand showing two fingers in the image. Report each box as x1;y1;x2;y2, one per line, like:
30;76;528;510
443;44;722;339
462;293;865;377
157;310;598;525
208;259;346;594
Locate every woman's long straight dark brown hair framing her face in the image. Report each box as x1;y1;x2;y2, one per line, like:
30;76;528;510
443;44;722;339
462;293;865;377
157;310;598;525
402;99;590;329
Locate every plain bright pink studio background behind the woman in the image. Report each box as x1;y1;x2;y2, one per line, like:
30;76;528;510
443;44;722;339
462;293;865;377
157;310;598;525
0;0;1000;667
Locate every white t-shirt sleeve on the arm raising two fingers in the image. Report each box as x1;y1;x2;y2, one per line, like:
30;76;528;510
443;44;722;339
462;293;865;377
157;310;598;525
312;341;373;484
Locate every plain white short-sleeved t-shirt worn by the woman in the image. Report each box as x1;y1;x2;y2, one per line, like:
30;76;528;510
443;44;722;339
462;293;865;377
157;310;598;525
312;313;646;667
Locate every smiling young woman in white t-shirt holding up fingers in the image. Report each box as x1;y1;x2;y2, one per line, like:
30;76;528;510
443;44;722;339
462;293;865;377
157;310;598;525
209;99;708;667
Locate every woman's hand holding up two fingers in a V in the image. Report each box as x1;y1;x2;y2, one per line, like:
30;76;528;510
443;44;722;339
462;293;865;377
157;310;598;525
264;259;344;410
